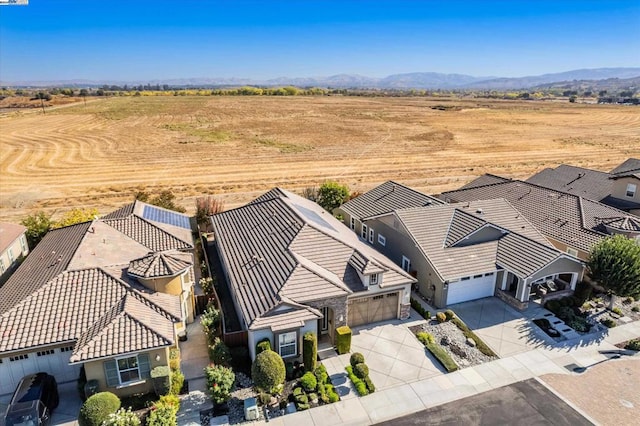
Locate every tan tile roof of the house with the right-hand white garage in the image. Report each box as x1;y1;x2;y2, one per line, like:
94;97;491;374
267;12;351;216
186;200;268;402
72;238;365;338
392;200;577;280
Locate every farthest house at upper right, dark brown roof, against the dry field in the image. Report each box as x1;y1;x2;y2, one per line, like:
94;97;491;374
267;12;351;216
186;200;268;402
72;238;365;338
527;158;640;216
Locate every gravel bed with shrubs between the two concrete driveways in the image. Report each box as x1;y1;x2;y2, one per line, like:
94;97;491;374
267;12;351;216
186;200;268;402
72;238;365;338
409;320;497;368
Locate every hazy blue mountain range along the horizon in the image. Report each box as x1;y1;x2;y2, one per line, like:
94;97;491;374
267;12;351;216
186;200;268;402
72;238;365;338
0;68;640;90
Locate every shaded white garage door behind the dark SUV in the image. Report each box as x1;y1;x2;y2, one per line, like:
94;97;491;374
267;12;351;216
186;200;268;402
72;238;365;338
0;347;80;395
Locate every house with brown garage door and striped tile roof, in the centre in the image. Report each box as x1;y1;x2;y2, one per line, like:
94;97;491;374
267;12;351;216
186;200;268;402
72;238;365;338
211;188;415;359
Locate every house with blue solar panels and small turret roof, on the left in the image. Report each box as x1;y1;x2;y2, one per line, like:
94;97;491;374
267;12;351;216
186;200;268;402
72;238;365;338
0;201;194;396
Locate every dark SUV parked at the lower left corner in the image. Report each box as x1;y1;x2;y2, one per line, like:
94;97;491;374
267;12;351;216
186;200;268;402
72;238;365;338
4;373;59;426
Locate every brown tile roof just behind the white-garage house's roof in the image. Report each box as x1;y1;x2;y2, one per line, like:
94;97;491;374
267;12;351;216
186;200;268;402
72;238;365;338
440;180;630;252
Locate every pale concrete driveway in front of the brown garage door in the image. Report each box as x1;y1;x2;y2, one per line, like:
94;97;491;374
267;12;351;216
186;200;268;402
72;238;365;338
322;312;444;392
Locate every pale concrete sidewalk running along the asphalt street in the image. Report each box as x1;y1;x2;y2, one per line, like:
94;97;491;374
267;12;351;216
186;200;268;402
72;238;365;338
258;321;640;426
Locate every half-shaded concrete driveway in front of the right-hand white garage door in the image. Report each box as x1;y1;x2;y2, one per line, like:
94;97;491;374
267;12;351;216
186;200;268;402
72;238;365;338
450;297;554;358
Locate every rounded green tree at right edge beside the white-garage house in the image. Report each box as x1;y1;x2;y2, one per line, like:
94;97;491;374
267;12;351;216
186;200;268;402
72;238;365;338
587;235;640;309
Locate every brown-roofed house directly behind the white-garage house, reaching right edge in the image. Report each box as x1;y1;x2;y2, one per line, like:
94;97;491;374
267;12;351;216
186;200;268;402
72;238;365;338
439;175;640;260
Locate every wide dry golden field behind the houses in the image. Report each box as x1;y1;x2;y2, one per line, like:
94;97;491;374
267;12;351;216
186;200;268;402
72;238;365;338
0;96;640;221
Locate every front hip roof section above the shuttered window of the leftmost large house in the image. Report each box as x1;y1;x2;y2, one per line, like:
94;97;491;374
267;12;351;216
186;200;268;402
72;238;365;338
70;293;175;363
